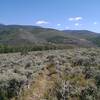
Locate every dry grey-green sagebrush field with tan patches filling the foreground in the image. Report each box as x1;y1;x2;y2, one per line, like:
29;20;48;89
0;48;100;100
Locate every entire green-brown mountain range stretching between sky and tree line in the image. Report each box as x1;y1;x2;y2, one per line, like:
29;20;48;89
0;24;100;47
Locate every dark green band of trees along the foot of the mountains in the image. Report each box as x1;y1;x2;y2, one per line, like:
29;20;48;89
0;44;73;55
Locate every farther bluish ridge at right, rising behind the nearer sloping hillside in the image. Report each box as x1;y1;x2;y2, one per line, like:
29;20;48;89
63;30;100;46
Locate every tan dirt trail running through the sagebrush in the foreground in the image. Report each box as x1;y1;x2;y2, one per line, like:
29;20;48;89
23;65;54;100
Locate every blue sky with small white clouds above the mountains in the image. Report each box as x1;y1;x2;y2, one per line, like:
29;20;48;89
0;0;100;32
